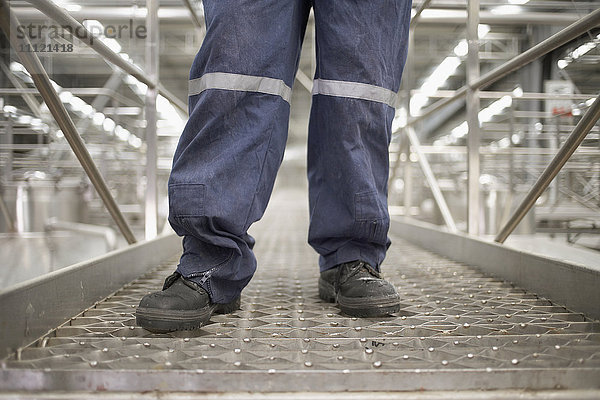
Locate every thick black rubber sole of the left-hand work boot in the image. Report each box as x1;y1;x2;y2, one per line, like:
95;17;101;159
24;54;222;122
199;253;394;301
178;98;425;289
135;297;240;333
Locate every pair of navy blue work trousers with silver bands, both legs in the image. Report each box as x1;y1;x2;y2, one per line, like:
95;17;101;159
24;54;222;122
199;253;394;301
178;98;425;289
169;0;410;303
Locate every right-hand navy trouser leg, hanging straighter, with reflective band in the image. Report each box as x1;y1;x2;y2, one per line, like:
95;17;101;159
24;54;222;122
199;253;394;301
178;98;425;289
308;0;411;271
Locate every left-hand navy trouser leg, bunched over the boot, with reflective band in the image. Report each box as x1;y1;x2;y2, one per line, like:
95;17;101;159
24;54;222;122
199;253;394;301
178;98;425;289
164;0;309;303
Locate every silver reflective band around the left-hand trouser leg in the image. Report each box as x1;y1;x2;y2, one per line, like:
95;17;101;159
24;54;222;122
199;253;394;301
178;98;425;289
189;72;292;103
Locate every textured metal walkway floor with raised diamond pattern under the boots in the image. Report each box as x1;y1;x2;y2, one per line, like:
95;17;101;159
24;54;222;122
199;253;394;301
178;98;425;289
2;191;600;392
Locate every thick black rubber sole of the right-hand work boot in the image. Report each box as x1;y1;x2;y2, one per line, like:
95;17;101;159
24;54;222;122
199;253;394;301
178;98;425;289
319;278;400;318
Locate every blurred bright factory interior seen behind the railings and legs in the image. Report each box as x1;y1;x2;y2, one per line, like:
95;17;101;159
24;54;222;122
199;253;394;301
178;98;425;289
0;0;600;286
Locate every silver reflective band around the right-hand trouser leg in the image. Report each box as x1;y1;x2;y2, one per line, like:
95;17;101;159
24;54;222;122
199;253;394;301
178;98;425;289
312;79;398;107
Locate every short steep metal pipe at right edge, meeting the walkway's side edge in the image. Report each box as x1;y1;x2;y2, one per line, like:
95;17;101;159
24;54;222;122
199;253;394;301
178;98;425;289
494;95;600;243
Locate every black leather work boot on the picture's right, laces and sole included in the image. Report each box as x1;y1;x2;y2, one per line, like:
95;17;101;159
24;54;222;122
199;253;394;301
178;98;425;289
319;260;400;318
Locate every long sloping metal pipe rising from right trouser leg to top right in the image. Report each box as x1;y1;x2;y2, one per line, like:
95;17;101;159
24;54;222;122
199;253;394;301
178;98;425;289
408;8;600;124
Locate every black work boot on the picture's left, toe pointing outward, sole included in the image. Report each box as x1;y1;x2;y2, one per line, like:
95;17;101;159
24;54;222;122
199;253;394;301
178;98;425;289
135;272;240;333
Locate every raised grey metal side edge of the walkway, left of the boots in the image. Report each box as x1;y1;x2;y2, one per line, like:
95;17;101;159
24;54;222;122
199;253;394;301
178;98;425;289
0;233;181;359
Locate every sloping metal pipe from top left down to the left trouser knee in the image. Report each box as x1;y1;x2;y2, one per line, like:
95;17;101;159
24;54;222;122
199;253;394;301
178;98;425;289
27;0;187;114
